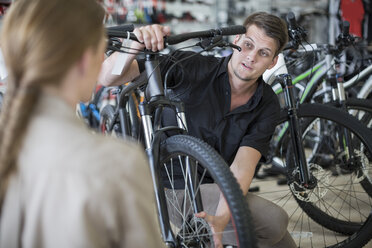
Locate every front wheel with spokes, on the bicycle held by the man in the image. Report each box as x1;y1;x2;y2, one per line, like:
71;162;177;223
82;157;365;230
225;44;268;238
160;135;256;247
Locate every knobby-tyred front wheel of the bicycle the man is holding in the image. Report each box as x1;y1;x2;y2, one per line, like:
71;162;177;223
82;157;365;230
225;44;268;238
160;135;256;247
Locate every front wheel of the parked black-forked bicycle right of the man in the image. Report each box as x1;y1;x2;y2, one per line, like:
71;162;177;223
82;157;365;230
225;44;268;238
287;105;372;247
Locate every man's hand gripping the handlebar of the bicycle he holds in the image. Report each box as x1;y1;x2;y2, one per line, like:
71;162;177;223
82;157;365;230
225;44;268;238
132;24;170;52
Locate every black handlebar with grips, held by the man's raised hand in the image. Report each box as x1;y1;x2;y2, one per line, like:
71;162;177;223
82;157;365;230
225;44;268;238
106;25;246;45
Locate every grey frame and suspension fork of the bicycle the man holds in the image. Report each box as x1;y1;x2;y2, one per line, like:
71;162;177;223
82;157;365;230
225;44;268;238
109;53;203;246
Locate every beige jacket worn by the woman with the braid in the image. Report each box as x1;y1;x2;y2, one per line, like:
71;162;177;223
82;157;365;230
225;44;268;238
0;96;164;248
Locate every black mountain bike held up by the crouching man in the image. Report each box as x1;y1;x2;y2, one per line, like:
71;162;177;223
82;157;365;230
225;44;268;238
100;26;255;247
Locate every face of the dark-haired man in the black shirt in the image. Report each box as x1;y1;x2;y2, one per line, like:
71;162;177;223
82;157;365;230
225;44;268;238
229;25;278;81
